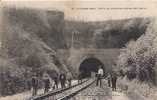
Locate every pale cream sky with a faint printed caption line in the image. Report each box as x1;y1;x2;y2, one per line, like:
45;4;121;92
1;0;157;21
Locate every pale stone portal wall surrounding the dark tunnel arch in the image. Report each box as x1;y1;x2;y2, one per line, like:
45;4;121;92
57;49;122;77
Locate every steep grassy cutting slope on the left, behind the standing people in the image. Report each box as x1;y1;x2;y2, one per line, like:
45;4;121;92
0;8;67;95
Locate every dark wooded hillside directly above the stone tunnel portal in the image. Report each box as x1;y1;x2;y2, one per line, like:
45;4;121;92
64;18;150;48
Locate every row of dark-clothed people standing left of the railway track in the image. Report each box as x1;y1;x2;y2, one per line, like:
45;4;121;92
31;72;72;96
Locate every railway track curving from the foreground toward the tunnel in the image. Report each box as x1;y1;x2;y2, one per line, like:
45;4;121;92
29;79;95;100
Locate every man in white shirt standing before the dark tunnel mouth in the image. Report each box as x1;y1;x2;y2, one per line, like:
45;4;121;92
96;66;104;87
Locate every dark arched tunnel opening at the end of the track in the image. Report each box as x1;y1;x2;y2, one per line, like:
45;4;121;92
79;58;104;78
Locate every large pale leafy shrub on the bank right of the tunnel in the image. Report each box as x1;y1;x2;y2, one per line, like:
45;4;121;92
117;19;157;84
